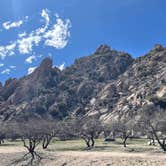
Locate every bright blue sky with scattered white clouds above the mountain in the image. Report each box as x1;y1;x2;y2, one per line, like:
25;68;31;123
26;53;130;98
0;0;166;83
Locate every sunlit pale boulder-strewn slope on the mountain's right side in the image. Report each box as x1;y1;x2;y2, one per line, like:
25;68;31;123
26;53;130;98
89;45;166;121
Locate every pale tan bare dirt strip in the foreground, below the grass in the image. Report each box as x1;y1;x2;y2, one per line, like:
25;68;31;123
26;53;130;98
0;146;166;166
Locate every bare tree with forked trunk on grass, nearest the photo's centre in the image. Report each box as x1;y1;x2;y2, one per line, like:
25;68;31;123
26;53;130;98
59;117;102;149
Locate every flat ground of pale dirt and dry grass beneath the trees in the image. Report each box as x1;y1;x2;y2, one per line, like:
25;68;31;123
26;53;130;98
0;139;166;166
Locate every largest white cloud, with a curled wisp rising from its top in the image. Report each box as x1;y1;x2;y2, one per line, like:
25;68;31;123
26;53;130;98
17;13;71;54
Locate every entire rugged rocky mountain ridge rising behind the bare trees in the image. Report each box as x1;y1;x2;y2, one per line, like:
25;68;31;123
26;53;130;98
0;45;166;122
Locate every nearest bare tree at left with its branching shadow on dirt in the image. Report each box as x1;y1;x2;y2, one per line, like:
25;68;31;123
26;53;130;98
6;119;43;165
